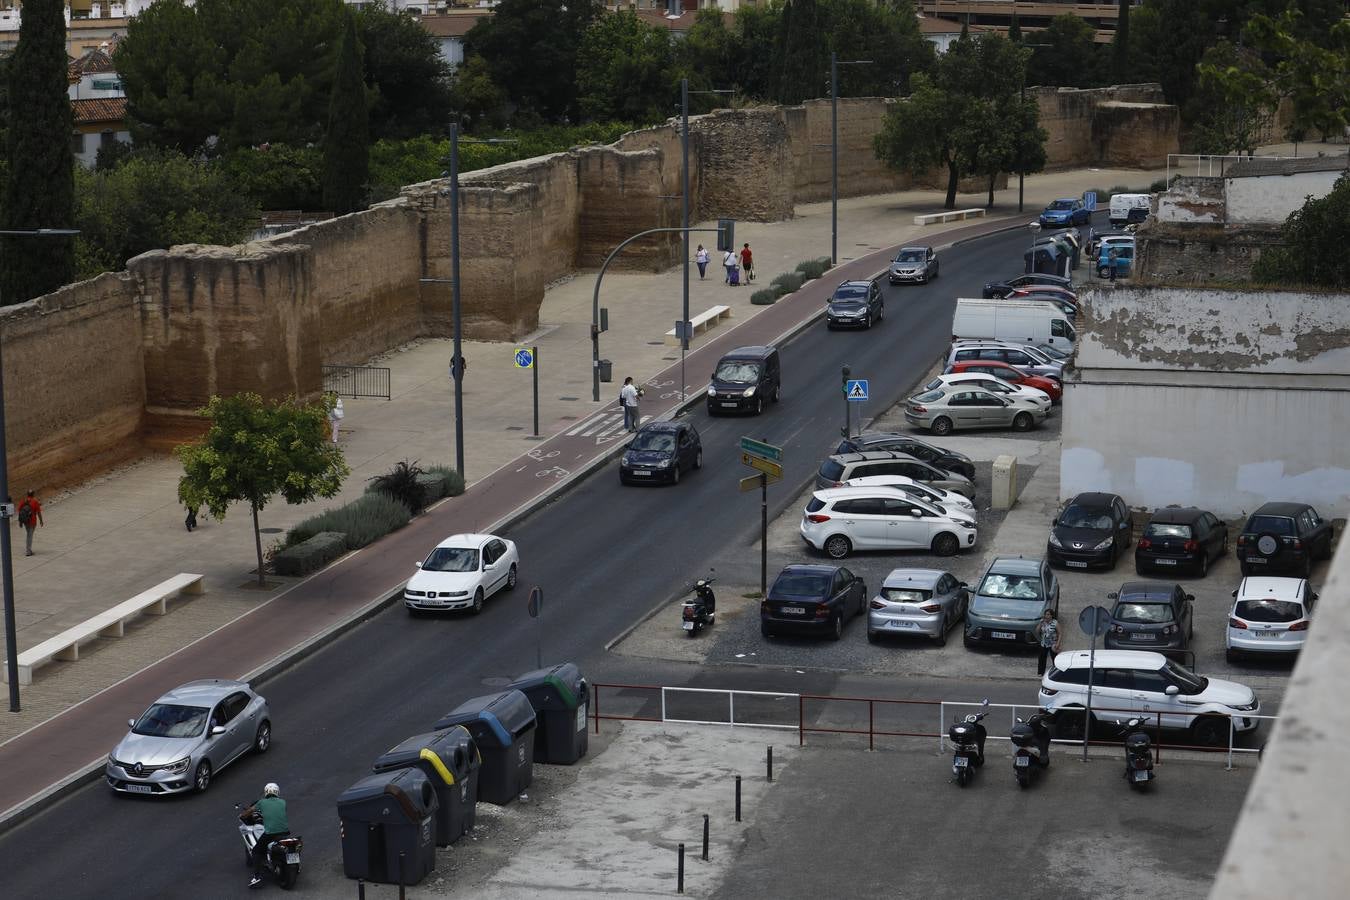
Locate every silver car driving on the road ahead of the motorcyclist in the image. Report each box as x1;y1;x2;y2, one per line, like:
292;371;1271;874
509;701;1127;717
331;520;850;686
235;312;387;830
104;679;271;796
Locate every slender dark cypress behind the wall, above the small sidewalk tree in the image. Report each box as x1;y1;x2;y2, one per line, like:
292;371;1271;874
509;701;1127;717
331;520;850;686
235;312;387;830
323;13;370;216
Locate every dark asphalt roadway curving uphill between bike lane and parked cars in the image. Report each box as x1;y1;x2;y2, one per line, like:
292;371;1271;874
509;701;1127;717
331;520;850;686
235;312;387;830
0;221;1074;897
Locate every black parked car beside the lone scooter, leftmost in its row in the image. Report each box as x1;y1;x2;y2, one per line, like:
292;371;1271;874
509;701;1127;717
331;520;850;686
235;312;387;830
760;565;867;641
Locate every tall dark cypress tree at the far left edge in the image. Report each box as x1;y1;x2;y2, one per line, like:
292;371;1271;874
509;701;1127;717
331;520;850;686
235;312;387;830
0;0;76;305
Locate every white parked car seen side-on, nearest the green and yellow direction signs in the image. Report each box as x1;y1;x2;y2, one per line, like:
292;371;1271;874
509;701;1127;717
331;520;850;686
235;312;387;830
799;487;976;560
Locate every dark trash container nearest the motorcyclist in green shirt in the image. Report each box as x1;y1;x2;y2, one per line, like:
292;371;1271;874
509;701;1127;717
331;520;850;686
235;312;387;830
338;769;436;884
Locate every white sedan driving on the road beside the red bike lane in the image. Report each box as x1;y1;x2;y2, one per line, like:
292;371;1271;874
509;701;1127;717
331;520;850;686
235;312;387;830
404;534;520;615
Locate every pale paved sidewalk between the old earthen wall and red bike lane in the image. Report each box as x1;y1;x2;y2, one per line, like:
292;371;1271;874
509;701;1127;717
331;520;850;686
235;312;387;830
0;170;1158;750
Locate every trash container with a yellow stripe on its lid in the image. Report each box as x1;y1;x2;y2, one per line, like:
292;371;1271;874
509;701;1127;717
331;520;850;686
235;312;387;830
370;725;479;847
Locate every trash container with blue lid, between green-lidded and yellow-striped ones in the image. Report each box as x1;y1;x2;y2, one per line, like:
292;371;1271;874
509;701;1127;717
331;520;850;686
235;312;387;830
432;691;535;806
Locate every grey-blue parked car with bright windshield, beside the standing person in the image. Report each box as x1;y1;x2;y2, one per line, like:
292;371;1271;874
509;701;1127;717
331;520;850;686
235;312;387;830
963;556;1062;648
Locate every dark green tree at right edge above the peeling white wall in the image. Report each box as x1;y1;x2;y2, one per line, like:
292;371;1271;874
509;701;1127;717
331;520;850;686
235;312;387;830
1251;175;1350;290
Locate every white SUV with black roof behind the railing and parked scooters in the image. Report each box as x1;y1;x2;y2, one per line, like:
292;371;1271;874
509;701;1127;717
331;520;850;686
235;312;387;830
1040;650;1261;745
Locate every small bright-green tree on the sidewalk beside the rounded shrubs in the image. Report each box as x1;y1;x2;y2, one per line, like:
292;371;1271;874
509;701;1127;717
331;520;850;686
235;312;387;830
174;394;351;586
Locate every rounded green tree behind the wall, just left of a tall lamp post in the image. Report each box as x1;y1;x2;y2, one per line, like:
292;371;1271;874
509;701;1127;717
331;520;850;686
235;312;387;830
576;9;679;123
